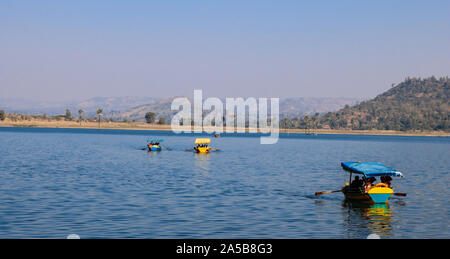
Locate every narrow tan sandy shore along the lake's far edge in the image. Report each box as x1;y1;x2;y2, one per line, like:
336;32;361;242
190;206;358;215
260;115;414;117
0;120;450;137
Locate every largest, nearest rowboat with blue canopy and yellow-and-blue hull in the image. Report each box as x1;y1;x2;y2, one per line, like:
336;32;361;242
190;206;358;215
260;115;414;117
341;162;403;204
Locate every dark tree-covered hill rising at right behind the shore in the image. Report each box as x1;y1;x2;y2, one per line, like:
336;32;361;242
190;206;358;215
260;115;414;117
319;77;450;131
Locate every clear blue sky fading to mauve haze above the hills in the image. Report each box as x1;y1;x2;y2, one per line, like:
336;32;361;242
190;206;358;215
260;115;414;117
0;0;450;100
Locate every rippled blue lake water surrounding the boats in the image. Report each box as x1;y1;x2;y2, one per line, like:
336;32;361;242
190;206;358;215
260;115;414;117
0;128;450;238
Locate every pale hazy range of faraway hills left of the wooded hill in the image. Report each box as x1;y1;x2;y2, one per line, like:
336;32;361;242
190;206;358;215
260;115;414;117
0;96;360;121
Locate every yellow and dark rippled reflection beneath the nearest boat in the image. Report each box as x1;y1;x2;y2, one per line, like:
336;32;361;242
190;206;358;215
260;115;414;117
343;201;392;238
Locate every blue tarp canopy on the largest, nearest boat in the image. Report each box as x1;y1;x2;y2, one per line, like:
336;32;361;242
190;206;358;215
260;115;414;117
341;162;403;178
